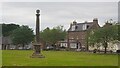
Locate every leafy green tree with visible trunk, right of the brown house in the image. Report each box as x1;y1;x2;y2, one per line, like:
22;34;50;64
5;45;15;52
89;25;118;53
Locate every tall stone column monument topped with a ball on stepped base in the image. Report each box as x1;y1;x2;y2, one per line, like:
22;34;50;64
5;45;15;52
31;10;45;58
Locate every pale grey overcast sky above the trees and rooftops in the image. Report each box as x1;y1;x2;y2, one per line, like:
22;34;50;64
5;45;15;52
2;2;118;30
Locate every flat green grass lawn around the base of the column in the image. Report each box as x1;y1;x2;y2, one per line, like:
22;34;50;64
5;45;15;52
2;50;118;66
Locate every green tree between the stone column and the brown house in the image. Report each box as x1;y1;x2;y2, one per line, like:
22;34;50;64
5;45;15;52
40;26;66;45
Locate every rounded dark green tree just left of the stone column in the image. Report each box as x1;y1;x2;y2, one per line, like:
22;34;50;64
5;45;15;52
11;26;34;48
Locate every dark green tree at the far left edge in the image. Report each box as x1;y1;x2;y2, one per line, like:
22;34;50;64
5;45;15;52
2;24;19;37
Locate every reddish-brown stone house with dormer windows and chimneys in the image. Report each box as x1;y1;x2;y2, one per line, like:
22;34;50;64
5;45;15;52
60;18;100;50
